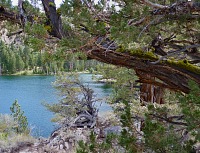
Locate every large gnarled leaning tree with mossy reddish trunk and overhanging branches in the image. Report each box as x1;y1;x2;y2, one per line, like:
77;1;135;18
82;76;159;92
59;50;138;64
0;0;200;103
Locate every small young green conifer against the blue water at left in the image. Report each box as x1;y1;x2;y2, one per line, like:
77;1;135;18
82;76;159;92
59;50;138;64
10;100;28;133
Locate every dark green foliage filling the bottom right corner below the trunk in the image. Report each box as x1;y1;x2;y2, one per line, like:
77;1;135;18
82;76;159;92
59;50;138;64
143;81;200;153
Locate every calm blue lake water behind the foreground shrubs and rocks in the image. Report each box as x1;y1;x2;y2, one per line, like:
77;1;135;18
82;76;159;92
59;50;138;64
0;74;111;137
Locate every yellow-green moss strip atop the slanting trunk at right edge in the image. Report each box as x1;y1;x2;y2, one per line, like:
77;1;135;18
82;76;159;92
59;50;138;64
166;60;200;74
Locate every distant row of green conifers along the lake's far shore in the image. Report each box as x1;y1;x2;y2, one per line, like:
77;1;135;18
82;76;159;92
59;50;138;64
0;42;102;75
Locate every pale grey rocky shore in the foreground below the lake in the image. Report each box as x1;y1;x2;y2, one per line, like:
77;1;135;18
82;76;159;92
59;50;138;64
0;113;122;153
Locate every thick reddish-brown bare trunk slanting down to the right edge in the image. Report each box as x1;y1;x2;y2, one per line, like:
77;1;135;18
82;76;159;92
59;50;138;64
82;42;200;93
